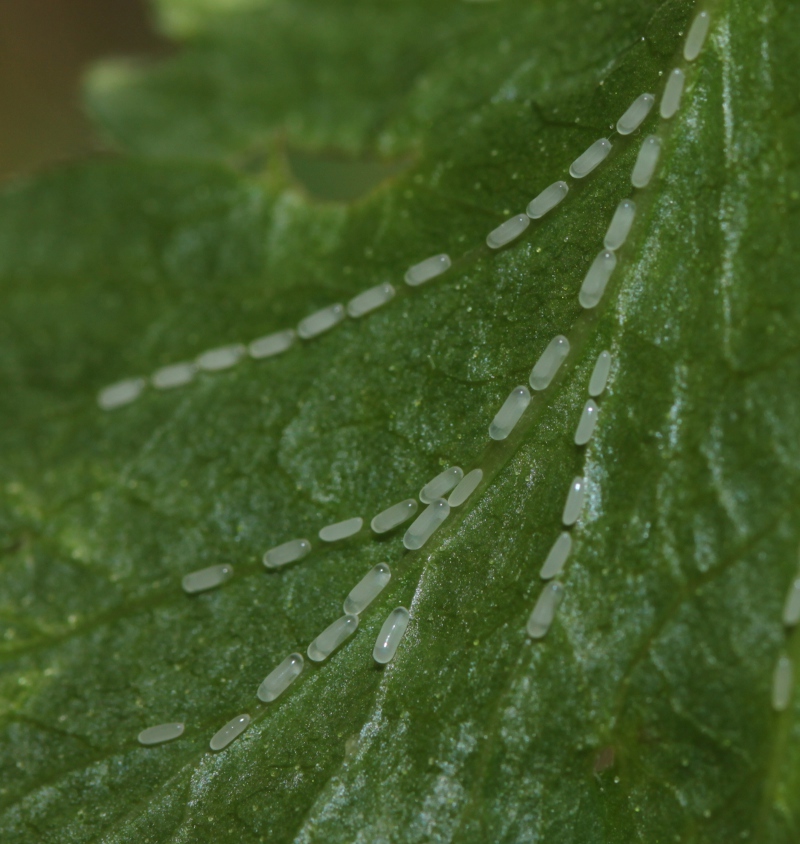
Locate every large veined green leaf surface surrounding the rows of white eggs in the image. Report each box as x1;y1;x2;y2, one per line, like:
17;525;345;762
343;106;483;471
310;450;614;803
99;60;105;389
0;0;800;844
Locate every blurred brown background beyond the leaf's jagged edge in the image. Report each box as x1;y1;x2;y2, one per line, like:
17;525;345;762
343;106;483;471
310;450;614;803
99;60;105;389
0;0;167;181
